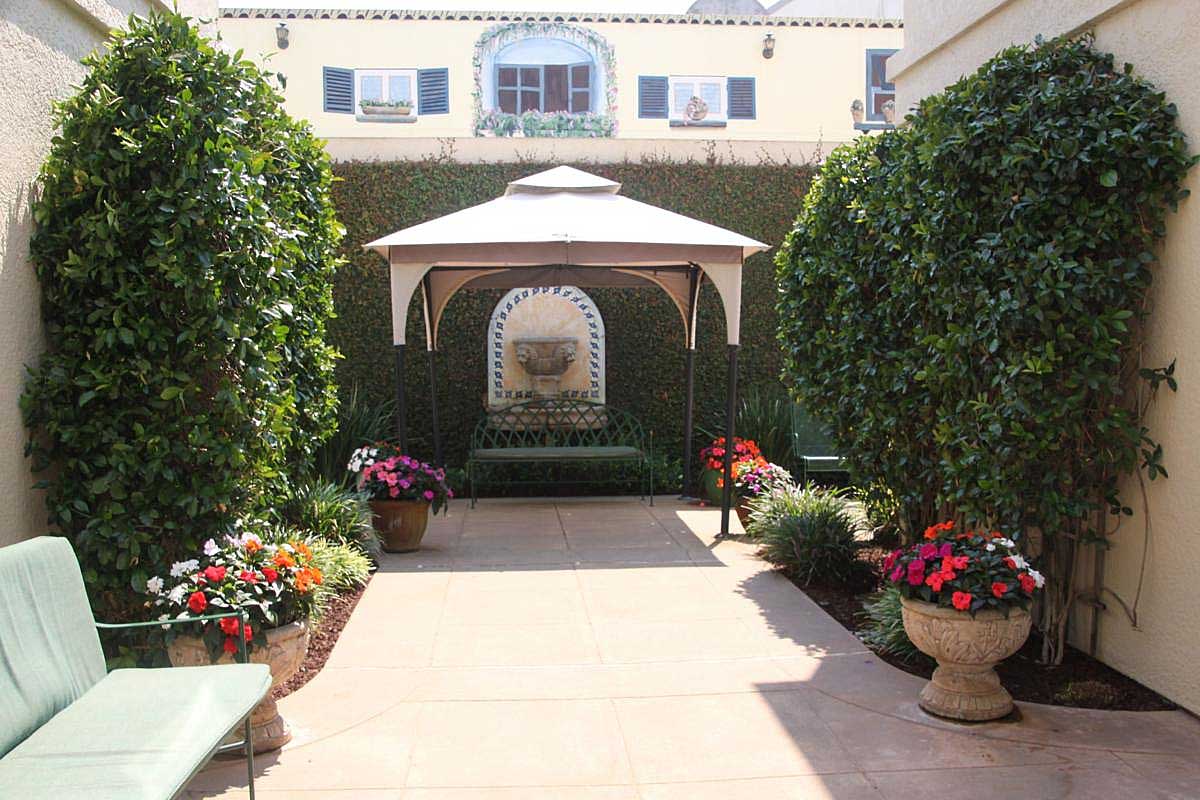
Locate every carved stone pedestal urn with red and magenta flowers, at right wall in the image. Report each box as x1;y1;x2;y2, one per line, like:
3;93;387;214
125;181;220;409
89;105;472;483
883;522;1045;722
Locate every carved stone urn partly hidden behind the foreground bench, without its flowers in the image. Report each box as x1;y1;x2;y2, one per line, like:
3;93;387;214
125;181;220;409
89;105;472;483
167;621;308;753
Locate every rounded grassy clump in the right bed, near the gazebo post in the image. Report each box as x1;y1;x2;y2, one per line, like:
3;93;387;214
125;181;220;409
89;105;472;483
751;487;870;585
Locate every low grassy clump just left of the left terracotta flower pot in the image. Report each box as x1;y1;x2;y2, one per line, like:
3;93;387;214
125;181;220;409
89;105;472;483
275;481;378;552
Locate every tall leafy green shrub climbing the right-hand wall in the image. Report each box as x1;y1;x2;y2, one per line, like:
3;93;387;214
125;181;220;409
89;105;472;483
776;40;1193;660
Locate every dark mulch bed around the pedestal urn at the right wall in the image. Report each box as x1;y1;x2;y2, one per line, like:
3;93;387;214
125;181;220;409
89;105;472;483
799;546;1178;711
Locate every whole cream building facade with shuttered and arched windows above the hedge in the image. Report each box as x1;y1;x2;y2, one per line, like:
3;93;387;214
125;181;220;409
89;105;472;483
218;6;902;160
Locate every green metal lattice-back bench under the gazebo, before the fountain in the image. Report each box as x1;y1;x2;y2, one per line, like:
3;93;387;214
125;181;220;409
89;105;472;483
467;398;654;509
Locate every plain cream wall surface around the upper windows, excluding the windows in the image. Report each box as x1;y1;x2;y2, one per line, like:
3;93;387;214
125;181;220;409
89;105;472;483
218;18;904;149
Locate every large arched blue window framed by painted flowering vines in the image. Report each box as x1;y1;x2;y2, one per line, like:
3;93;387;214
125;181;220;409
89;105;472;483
475;23;616;137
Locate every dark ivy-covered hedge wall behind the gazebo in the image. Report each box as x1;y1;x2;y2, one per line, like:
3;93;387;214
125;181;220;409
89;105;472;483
330;158;812;465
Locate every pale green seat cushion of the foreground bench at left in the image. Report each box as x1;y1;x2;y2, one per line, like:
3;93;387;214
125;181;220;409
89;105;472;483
0;664;271;800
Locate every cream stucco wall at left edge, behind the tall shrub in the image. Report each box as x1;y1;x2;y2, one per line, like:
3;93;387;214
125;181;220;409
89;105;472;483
0;0;216;546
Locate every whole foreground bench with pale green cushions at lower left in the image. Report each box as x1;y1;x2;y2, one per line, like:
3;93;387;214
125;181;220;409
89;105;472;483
0;536;271;800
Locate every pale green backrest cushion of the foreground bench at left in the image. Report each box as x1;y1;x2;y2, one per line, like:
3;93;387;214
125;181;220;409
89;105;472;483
0;536;104;758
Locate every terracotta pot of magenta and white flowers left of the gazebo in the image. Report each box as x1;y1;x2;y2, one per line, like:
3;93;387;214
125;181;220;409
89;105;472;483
347;441;454;553
